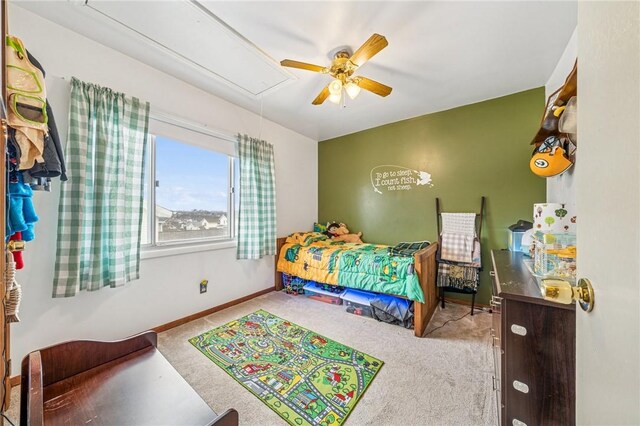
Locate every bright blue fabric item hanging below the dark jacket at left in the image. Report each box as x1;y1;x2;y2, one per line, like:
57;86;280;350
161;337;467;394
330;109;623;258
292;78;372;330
6;173;38;241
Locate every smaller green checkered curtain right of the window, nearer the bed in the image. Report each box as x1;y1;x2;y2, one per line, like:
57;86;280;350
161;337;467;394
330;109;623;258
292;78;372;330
237;135;276;259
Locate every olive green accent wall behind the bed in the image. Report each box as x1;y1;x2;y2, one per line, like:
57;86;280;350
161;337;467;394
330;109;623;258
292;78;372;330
318;87;546;304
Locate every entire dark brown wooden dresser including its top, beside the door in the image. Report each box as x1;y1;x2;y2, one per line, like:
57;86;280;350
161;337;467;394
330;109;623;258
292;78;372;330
491;250;576;426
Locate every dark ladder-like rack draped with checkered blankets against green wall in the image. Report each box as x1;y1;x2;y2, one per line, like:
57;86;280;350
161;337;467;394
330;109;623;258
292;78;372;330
436;197;485;315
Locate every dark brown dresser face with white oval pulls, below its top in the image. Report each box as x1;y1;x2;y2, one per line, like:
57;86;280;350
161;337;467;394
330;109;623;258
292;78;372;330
502;300;575;425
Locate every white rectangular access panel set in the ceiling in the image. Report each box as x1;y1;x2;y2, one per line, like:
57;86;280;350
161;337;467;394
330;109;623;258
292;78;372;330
86;0;293;97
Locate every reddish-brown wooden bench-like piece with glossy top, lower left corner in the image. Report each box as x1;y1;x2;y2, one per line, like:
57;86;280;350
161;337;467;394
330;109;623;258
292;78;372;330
20;331;238;426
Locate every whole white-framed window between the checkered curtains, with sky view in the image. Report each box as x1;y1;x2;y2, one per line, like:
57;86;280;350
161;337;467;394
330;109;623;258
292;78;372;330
141;118;238;248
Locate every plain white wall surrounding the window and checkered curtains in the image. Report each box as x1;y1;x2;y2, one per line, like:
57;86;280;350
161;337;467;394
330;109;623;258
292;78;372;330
9;5;318;374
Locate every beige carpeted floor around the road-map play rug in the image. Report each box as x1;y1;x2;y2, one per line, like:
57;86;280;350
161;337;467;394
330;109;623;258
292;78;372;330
2;292;497;426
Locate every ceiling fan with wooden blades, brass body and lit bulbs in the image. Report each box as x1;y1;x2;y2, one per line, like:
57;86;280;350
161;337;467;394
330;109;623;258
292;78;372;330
280;34;392;105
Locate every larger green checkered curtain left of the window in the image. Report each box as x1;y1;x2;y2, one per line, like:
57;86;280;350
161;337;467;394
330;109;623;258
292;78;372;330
53;78;149;297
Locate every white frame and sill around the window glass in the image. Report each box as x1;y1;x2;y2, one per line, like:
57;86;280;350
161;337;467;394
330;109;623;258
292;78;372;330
140;114;239;259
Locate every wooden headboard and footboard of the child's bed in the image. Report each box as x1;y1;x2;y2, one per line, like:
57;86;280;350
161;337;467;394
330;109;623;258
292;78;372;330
275;237;438;337
